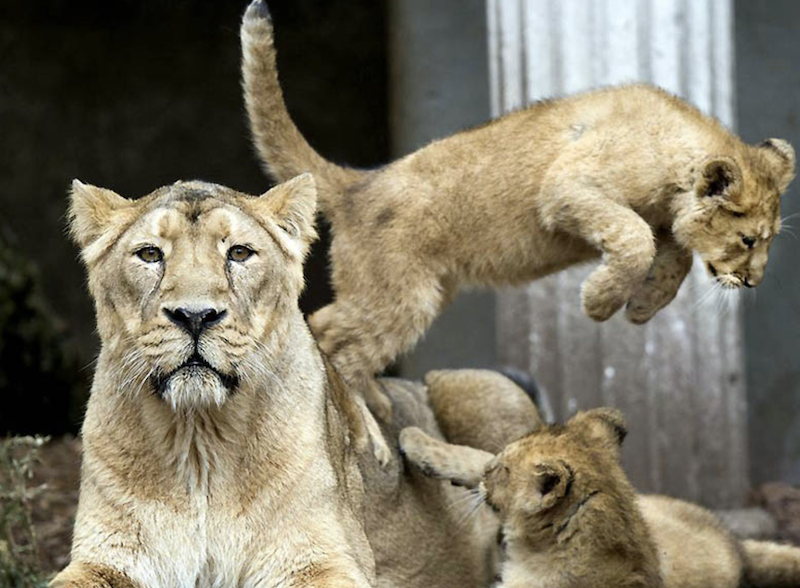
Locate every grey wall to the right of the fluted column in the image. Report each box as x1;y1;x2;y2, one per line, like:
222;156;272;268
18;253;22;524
736;0;800;484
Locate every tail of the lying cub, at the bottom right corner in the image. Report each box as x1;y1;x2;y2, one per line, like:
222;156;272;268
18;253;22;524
742;540;800;588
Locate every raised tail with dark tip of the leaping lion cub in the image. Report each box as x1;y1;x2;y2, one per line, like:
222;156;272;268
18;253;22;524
241;0;369;216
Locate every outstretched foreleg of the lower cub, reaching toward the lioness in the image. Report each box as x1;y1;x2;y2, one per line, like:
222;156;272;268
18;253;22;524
400;427;494;488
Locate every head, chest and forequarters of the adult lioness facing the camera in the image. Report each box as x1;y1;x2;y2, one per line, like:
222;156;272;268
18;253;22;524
52;174;375;588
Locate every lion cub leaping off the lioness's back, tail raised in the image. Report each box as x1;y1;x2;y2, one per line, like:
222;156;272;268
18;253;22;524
242;0;795;428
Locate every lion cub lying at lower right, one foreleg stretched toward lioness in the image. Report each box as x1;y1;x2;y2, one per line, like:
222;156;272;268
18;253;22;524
400;409;800;588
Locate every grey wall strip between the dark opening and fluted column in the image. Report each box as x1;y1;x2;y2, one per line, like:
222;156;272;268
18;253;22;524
388;0;495;378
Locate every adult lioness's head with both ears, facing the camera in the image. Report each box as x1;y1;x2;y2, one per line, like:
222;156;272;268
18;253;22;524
71;175;316;410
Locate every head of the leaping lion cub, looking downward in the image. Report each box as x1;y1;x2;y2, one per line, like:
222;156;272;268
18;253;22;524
673;139;795;288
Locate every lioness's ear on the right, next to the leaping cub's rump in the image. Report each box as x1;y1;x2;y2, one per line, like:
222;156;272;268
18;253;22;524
252;173;317;258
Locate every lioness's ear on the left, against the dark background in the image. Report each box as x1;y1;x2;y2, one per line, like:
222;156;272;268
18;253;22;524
68;180;134;249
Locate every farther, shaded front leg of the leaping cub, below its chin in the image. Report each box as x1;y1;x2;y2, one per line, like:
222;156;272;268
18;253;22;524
625;233;692;325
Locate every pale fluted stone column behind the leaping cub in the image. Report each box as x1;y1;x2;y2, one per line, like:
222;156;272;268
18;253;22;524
487;0;749;508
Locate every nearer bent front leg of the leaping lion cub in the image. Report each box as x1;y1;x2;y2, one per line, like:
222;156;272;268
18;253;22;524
543;191;656;321
